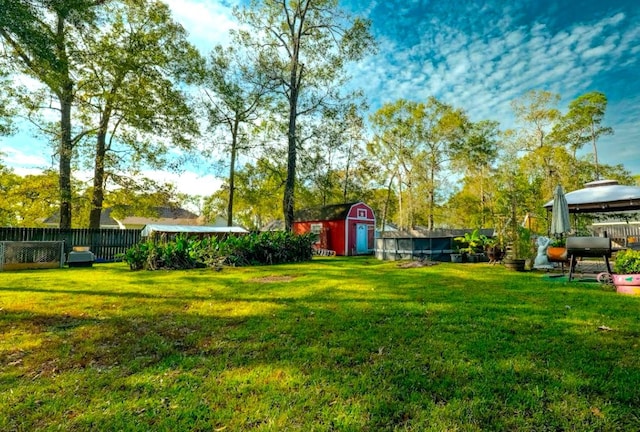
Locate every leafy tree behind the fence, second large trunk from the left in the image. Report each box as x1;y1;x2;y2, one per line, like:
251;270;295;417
78;0;202;228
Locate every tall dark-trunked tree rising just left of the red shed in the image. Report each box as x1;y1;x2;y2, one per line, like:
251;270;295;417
237;0;373;230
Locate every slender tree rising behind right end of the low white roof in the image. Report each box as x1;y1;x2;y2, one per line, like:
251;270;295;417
204;46;272;226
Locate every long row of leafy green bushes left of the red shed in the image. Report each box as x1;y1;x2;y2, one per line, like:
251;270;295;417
123;232;314;270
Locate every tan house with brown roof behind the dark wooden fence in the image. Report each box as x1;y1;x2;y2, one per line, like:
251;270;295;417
44;207;202;229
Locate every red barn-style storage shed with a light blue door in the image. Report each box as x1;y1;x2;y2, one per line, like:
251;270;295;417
293;202;376;255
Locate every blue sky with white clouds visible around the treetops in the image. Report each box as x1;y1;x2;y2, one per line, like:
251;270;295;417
0;0;640;194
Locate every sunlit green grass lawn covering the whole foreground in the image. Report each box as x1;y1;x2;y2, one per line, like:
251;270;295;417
0;258;640;431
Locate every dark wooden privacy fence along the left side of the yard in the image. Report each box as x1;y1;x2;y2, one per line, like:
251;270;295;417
0;227;141;262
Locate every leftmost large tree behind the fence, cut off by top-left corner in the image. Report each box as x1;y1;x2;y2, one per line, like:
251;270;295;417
0;0;105;228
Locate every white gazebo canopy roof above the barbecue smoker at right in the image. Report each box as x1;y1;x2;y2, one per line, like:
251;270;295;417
544;180;640;213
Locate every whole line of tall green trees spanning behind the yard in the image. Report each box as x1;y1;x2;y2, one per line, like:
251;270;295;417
0;0;630;243
